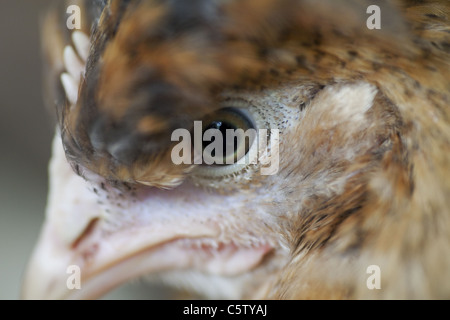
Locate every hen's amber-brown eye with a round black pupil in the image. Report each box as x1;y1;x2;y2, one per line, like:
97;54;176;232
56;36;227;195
201;107;256;165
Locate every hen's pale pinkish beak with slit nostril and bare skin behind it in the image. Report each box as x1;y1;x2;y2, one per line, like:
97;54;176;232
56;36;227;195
22;134;272;299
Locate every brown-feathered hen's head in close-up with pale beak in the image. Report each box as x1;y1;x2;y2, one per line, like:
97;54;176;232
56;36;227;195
23;0;450;299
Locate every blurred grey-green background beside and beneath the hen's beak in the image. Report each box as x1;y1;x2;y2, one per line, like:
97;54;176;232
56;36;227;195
0;0;160;299
